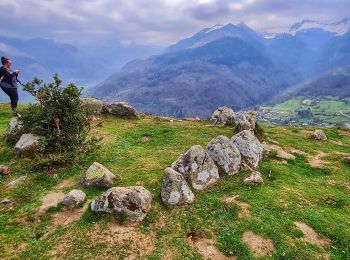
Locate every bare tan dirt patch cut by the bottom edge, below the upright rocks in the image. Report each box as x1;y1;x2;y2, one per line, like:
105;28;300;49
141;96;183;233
187;235;237;260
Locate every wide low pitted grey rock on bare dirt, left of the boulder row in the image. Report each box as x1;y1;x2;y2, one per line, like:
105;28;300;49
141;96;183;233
91;186;152;221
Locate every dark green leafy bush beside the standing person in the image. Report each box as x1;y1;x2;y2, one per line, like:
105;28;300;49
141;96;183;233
21;74;90;160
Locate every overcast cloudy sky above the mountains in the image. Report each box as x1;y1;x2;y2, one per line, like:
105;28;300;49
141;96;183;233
0;0;350;46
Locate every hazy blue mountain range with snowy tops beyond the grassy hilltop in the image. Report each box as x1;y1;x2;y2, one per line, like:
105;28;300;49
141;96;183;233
89;19;350;117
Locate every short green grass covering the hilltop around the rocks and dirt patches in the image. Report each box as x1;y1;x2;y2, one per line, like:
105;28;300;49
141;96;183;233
0;102;350;259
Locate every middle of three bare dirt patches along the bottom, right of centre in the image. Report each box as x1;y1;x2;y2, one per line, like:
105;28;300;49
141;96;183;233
242;231;275;257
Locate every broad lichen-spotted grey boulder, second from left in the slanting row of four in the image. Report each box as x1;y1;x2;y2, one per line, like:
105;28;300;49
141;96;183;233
171;145;220;190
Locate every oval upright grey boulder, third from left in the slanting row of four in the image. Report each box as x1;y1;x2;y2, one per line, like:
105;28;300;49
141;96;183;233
206;135;241;175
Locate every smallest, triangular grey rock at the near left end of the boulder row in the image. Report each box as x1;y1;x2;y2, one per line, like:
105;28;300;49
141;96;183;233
161;167;194;206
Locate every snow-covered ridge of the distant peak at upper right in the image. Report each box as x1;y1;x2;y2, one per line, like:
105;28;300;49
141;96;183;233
289;18;350;35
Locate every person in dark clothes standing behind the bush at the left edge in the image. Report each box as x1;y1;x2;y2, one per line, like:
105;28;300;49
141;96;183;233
0;57;20;114
